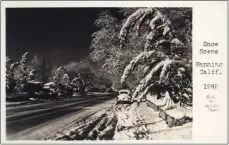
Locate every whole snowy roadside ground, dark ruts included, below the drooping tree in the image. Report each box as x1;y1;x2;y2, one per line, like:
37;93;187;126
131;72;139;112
46;102;192;140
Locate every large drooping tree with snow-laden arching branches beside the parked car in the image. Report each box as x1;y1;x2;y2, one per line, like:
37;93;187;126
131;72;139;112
120;8;192;105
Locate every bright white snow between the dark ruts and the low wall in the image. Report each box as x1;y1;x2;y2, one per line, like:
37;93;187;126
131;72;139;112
113;103;192;140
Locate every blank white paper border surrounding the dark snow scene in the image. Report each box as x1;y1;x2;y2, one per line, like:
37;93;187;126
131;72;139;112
1;1;227;144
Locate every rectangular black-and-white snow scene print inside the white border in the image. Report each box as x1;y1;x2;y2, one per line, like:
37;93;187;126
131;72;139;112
2;5;192;141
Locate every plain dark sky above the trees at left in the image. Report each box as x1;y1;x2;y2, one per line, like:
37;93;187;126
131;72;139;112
6;8;120;65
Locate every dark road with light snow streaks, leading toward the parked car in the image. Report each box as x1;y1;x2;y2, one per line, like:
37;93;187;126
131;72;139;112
6;96;116;140
